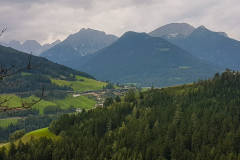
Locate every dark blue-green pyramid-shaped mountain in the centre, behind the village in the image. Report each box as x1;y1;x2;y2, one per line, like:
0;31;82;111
79;32;222;87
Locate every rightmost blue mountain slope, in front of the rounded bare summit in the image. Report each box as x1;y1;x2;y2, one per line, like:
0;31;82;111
164;26;240;70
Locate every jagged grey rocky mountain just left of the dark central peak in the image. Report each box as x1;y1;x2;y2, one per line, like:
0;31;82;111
41;28;117;66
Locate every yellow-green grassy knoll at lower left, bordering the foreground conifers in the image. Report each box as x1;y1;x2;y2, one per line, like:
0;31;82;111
4;128;62;148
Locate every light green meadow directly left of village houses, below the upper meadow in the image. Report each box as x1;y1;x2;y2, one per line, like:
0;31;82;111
53;95;96;109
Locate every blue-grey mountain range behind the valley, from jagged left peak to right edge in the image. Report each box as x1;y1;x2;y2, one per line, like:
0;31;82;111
2;23;240;86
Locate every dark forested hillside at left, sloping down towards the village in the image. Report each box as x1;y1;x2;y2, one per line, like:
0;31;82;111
0;45;95;94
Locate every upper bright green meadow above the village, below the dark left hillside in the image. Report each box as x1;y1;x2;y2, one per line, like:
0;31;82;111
51;75;107;91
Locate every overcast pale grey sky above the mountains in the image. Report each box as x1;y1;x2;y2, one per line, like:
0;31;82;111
0;0;240;44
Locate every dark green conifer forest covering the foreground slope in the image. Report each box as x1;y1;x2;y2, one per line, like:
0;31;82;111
0;70;240;160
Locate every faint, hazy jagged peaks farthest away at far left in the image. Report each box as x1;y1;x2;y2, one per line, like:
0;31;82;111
0;40;61;56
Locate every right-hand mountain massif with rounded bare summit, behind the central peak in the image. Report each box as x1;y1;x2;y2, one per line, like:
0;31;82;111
148;23;240;70
